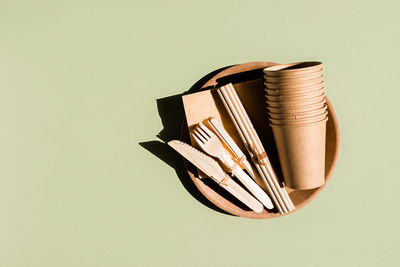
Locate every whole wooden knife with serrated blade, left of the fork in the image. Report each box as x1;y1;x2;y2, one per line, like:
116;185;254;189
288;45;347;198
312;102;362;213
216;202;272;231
168;140;263;213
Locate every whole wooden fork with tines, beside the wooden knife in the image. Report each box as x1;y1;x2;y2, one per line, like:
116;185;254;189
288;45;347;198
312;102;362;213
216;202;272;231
192;123;274;209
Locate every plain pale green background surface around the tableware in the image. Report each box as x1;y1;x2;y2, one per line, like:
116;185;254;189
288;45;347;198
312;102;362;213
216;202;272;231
0;0;400;267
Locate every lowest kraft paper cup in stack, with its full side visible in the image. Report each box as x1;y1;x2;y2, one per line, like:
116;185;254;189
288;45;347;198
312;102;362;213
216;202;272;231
271;119;328;189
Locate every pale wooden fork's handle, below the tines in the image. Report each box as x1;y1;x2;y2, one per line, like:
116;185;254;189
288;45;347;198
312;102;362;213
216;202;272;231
221;153;274;209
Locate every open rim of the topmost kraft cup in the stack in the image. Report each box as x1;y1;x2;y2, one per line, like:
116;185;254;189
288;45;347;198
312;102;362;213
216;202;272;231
263;61;322;77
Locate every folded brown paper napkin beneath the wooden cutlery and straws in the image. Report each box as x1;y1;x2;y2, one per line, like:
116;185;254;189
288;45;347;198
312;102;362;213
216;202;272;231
182;79;278;190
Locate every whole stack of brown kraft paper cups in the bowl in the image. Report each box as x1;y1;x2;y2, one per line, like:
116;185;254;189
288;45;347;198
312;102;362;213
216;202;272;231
264;62;328;189
